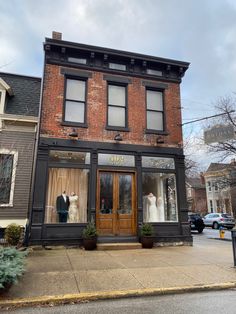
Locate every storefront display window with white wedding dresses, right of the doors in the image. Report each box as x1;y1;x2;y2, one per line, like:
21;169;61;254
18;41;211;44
142;172;178;222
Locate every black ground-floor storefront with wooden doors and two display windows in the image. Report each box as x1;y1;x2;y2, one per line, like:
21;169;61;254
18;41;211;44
31;139;191;244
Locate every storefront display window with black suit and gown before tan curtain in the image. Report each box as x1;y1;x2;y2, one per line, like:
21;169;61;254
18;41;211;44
45;168;89;223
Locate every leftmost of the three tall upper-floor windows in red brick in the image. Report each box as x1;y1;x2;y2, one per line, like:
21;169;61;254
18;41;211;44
64;78;86;124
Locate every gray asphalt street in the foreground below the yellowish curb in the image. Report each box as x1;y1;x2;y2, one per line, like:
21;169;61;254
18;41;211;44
2;290;236;314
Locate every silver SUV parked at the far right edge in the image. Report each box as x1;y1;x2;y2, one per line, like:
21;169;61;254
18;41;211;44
203;213;235;229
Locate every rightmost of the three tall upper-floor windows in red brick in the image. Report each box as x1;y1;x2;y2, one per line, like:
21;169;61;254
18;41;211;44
146;89;164;131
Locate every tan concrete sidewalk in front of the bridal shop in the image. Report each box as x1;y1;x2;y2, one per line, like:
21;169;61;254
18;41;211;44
0;240;236;305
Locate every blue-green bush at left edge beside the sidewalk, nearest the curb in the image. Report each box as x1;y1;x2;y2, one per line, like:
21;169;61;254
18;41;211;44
0;247;27;288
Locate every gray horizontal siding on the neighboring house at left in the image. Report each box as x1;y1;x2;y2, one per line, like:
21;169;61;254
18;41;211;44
0;131;35;221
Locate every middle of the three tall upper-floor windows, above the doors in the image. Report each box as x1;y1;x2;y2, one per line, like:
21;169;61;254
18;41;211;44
107;84;127;128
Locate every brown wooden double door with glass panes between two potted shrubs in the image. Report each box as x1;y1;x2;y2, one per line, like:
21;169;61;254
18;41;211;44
96;171;137;236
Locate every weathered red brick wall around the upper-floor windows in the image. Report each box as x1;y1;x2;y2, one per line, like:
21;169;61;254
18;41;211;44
40;64;182;147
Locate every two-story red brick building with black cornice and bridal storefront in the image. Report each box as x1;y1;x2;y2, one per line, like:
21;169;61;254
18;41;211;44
30;32;192;243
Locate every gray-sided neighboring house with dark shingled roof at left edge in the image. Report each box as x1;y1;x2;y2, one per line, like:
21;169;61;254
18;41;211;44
0;72;41;228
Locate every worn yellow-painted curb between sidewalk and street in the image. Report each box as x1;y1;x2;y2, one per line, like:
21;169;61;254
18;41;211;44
0;281;236;309
